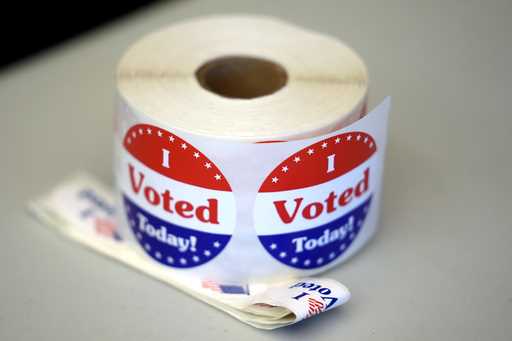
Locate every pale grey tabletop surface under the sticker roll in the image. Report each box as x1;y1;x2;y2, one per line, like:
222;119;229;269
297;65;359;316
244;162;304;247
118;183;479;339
0;0;512;341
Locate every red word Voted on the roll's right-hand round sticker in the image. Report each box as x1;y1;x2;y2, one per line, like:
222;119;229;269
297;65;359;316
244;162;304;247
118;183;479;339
273;168;370;224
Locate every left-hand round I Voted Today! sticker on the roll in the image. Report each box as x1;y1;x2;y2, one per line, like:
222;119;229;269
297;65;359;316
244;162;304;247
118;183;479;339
119;124;236;268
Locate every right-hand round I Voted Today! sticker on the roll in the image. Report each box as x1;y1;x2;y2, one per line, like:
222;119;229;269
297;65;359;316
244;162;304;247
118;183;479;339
254;131;377;269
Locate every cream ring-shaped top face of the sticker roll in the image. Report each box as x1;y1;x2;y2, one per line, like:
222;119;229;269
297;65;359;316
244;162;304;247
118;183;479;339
118;16;368;142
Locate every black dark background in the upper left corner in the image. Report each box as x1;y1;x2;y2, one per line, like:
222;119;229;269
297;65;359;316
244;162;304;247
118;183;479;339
0;0;163;69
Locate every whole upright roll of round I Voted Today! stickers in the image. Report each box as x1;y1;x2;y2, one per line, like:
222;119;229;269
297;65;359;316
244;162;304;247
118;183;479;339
115;16;385;283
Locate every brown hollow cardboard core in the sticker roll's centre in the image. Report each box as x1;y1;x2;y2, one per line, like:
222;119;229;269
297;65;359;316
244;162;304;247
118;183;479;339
196;56;288;99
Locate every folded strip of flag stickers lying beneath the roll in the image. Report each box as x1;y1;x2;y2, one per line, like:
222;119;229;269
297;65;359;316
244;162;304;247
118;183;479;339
30;174;350;329
